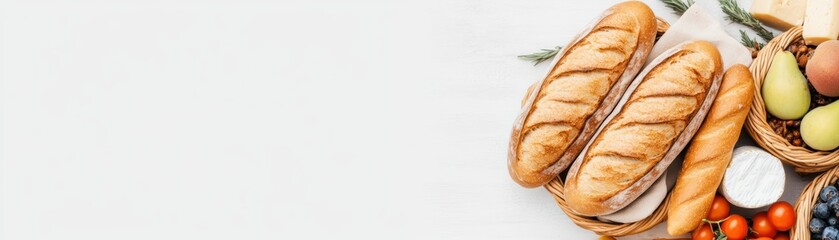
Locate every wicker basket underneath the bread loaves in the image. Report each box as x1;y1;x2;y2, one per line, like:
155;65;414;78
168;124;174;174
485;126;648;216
545;17;670;237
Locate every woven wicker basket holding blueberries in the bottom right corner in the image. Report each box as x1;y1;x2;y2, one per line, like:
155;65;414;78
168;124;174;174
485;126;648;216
790;167;839;240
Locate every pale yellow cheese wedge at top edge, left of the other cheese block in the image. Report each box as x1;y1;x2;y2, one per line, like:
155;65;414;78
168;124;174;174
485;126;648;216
749;0;807;31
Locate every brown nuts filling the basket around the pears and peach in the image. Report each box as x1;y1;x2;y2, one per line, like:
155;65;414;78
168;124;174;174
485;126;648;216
766;39;837;147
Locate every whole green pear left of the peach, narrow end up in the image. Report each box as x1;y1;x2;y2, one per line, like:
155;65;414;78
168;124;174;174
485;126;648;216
762;51;810;120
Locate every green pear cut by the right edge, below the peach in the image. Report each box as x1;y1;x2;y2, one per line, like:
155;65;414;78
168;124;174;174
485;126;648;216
801;101;839;151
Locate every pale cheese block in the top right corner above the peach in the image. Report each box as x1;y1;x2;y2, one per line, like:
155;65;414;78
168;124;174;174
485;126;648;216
803;0;839;45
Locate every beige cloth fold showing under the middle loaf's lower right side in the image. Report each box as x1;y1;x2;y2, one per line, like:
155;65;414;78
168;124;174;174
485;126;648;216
597;172;667;223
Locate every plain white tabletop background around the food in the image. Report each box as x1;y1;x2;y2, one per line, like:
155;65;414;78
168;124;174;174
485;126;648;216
0;0;800;240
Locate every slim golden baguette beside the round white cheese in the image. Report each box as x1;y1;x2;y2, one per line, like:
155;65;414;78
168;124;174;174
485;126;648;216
667;64;755;236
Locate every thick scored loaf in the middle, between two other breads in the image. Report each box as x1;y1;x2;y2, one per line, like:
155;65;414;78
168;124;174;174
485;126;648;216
565;41;722;216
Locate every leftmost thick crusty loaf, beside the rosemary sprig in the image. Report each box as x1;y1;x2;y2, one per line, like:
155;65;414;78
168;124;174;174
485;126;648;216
507;1;656;187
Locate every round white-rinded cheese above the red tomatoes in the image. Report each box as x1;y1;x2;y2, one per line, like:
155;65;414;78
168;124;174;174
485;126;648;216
720;146;786;208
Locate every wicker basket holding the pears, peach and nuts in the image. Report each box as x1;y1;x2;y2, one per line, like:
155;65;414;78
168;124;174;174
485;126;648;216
746;27;839;173
